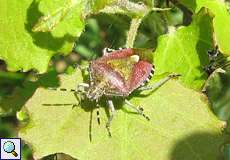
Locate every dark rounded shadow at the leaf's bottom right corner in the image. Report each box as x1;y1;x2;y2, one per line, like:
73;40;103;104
170;133;224;160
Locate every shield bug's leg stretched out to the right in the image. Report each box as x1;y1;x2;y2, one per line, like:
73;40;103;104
137;74;180;91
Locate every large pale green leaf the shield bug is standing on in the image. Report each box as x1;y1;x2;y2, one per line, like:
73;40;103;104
19;71;224;160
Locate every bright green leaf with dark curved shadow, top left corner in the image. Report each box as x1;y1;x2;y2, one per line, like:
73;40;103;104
0;0;84;73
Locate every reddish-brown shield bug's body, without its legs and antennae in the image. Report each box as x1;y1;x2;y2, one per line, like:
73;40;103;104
88;48;153;99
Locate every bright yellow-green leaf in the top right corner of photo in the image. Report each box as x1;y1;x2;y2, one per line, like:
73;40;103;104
180;0;230;55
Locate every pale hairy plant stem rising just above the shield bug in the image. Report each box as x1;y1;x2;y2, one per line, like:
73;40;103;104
126;17;142;48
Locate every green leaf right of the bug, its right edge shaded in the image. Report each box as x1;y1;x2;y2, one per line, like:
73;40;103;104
154;10;213;89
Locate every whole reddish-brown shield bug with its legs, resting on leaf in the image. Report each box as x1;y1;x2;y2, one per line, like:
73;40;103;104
51;48;178;136
